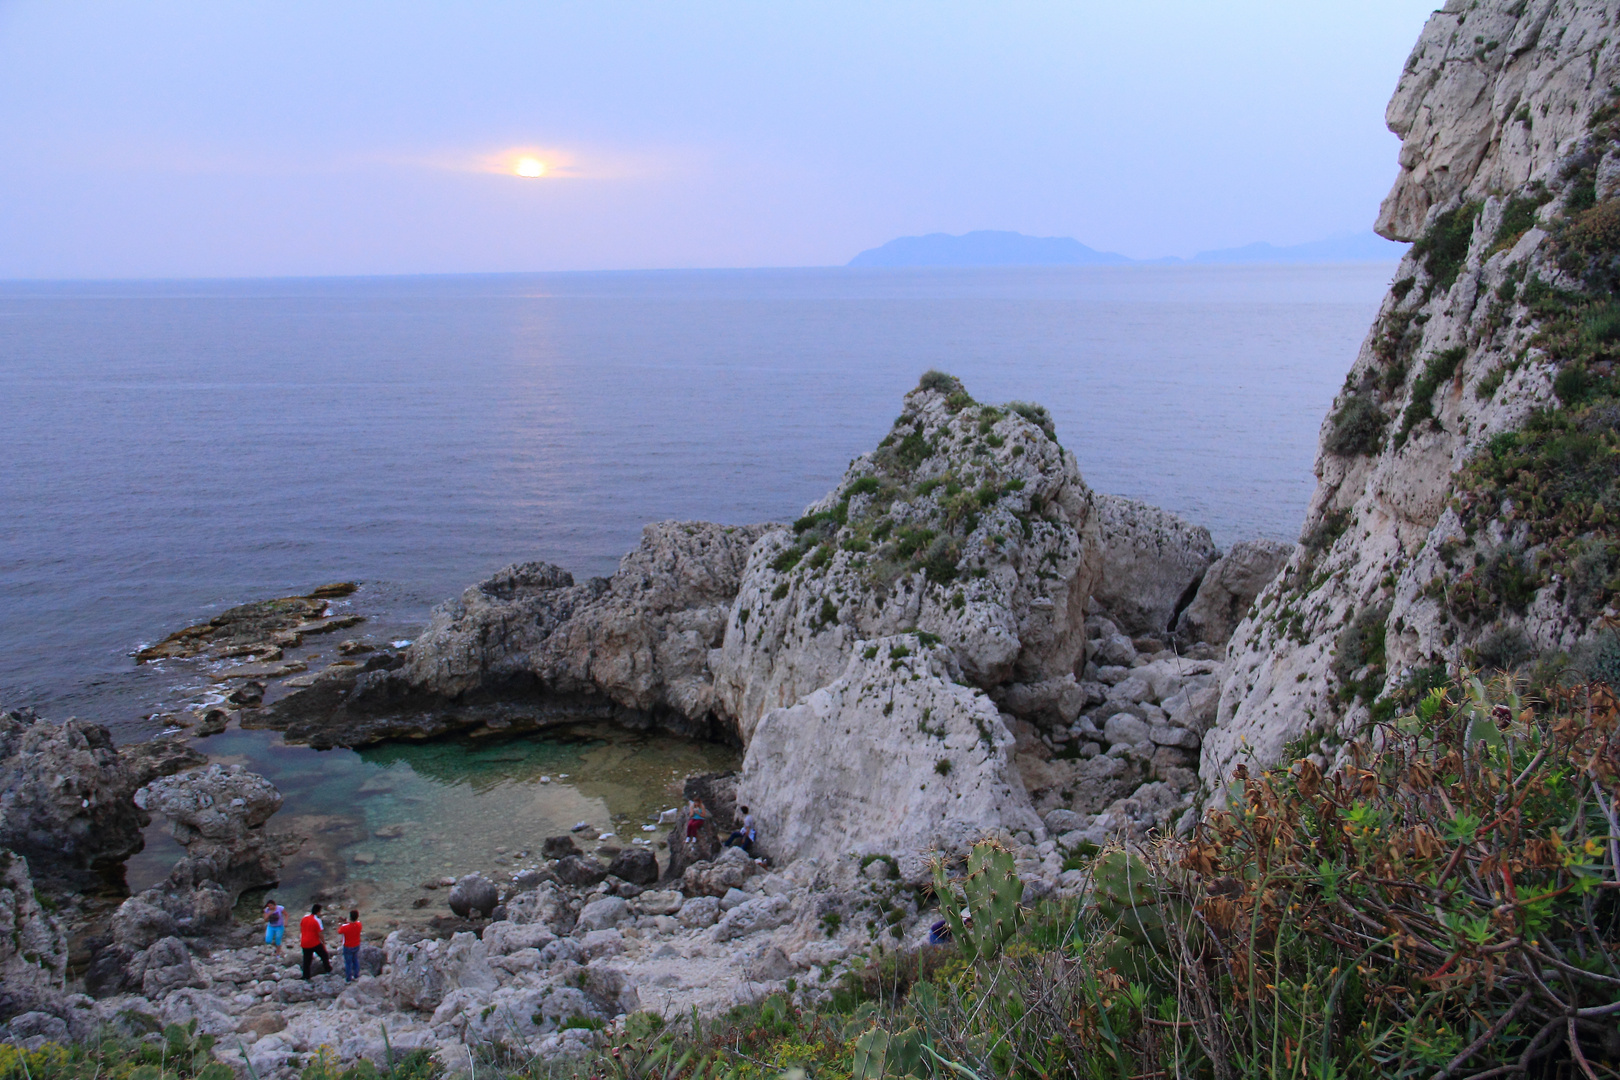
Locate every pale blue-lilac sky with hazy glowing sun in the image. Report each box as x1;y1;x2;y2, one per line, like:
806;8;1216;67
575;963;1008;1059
0;0;1434;279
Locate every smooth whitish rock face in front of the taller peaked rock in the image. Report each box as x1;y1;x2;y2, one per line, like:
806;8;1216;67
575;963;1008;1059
739;635;1040;860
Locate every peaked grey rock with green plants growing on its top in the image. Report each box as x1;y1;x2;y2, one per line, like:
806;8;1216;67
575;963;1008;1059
711;376;1098;742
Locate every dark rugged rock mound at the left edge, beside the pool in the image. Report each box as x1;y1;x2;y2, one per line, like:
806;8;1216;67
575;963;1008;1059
0;709;151;878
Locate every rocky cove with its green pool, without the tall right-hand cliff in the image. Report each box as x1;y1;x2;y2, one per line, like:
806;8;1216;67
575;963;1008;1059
5;372;1288;1075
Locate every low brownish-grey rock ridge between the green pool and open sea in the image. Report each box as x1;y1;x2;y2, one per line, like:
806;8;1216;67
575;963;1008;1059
259;521;761;746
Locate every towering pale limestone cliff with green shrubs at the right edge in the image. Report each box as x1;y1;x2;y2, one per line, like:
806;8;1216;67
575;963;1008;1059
1202;0;1620;787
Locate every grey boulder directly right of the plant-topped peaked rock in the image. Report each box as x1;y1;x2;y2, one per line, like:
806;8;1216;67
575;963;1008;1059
1092;495;1220;635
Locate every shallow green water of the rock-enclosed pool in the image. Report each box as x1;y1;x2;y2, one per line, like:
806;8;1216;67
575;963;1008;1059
126;725;739;931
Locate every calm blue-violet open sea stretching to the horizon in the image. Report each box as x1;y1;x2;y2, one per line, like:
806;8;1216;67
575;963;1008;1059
0;266;1392;738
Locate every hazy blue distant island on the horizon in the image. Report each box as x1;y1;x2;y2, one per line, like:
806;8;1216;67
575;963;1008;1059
849;228;1408;267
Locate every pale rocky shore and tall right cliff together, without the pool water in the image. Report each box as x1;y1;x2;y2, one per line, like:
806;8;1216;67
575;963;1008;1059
9;0;1620;1077
